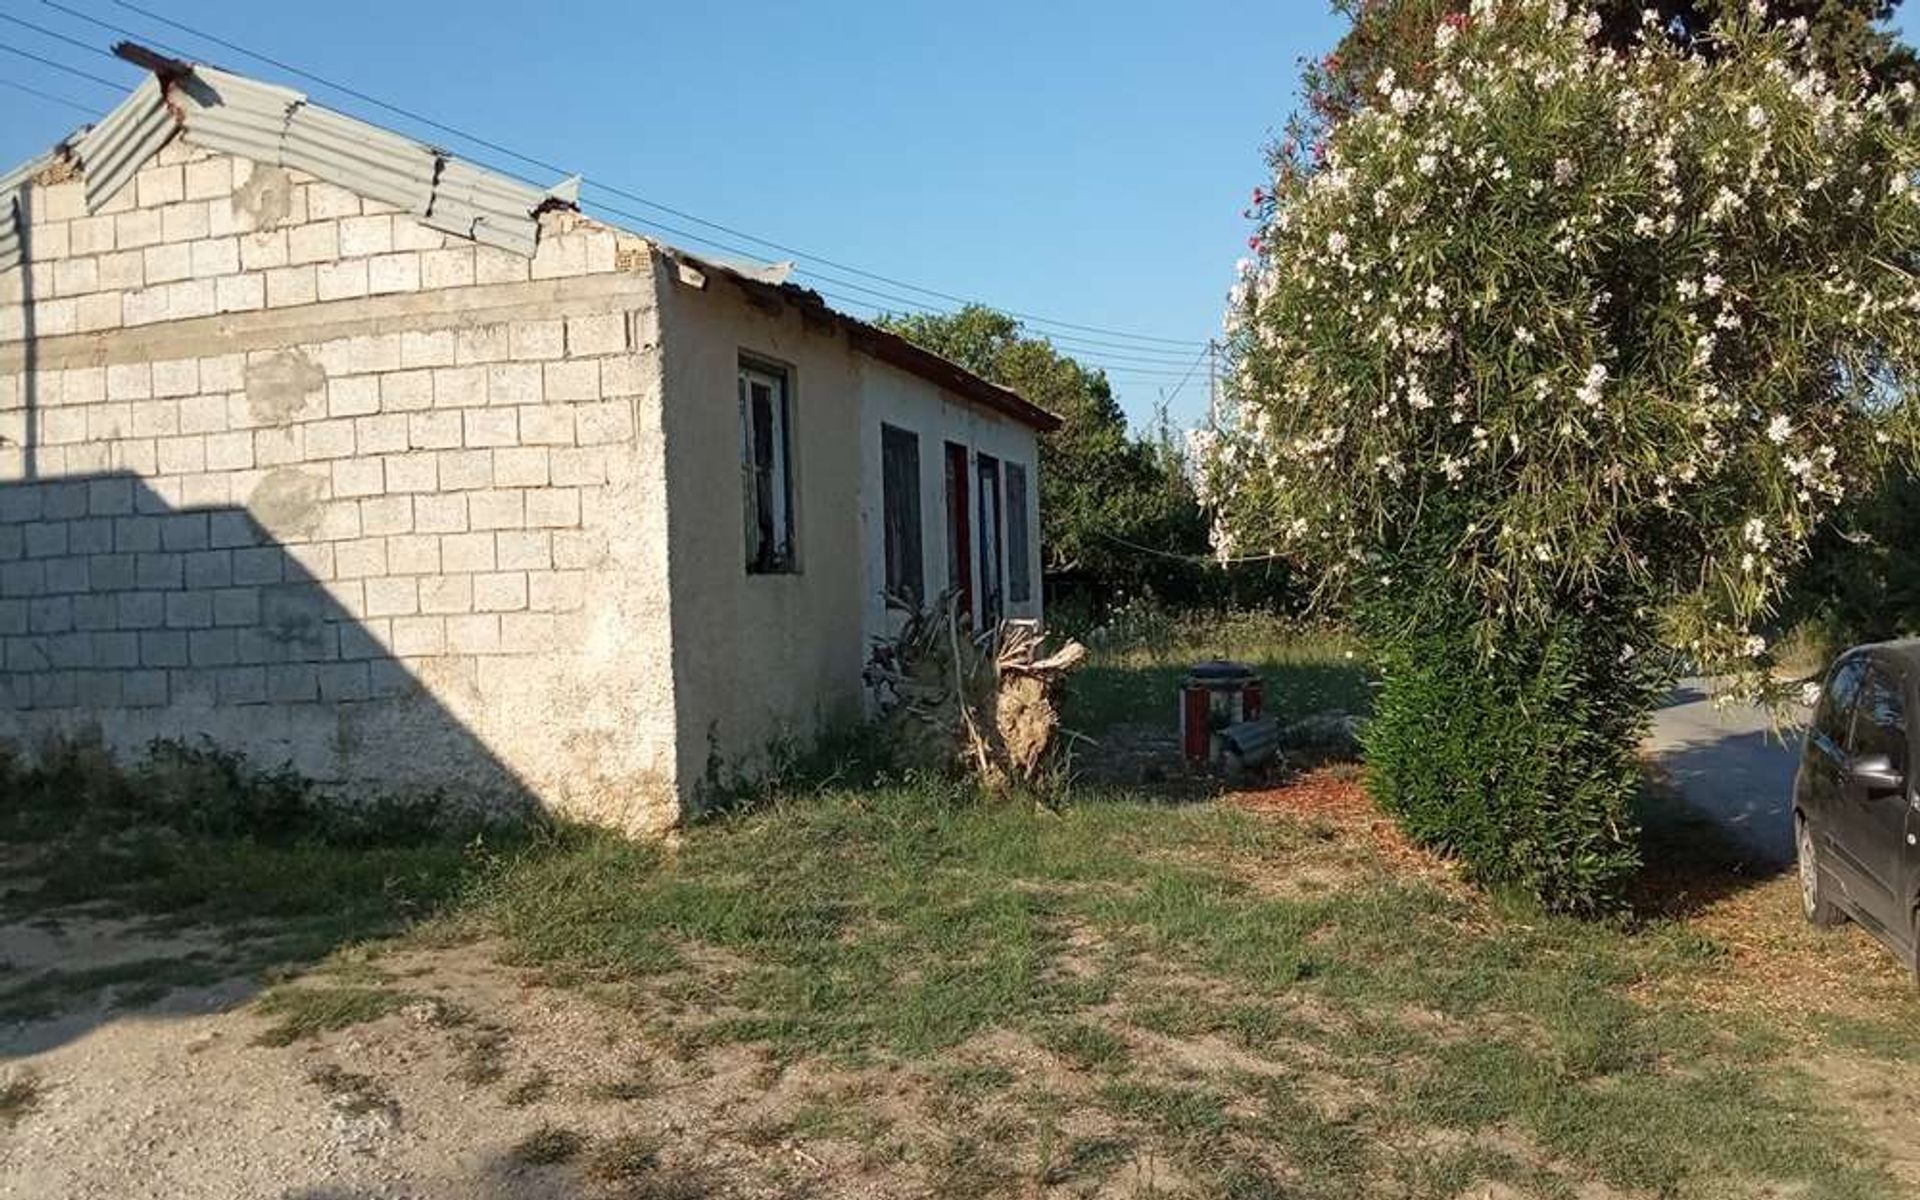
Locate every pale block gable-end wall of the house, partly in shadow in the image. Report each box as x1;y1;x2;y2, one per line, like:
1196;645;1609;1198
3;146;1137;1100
0;140;685;831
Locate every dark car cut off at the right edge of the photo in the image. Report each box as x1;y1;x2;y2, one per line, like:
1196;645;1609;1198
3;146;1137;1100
1793;639;1920;979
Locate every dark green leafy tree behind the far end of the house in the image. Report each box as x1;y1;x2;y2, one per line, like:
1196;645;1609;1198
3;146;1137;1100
881;305;1208;599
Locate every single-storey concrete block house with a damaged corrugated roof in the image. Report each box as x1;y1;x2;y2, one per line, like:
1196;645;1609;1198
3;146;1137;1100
0;56;1054;831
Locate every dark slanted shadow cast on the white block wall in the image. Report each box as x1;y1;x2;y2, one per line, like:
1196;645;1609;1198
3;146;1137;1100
0;472;534;812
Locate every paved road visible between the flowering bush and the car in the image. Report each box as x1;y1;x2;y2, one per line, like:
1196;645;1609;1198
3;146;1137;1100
1647;680;1805;866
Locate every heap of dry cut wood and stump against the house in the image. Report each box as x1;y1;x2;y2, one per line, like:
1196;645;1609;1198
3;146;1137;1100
866;595;1087;791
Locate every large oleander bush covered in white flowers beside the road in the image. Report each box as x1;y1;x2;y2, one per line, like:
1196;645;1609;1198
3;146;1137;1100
1204;0;1920;906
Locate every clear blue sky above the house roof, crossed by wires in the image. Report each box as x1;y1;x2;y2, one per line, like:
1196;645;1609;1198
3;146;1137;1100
0;0;1340;422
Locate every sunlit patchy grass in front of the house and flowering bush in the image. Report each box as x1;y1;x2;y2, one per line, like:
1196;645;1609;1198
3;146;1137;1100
445;787;1916;1198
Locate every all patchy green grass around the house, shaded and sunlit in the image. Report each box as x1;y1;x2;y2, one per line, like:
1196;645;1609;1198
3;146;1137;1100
0;625;1920;1200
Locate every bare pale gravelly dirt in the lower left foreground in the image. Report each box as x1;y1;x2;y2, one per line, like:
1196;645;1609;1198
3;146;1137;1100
0;933;837;1200
